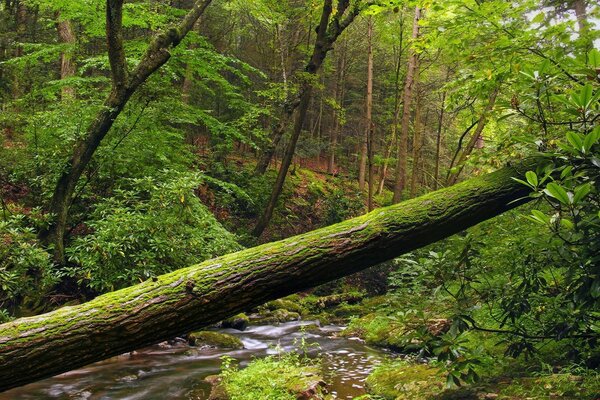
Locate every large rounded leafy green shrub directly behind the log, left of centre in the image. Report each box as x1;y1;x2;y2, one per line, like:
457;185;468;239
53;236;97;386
65;171;240;292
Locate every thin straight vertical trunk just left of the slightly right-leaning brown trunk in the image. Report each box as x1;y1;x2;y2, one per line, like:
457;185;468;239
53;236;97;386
361;16;374;211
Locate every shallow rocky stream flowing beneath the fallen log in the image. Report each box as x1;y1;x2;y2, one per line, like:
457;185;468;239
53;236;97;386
0;321;386;400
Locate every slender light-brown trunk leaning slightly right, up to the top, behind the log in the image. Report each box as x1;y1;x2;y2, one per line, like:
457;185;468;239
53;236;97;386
393;6;421;203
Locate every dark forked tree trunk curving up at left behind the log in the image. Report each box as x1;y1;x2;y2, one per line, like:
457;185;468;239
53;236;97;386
40;0;211;264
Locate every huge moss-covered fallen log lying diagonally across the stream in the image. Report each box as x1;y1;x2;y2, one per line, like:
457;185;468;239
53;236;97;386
0;161;527;391
